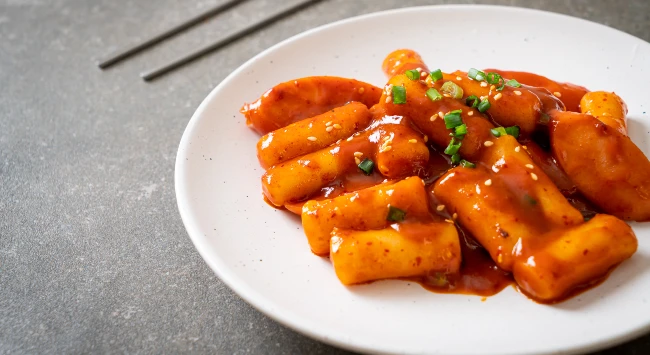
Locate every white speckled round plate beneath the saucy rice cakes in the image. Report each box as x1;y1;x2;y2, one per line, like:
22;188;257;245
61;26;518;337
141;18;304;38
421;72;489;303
175;6;650;354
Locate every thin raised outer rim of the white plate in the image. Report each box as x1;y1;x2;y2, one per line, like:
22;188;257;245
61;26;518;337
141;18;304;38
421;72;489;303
174;4;650;355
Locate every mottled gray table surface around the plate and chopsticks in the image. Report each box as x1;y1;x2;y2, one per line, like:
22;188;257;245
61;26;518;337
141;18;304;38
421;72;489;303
0;0;650;354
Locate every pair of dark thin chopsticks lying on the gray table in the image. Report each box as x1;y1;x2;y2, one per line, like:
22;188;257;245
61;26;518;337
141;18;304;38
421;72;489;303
98;0;321;81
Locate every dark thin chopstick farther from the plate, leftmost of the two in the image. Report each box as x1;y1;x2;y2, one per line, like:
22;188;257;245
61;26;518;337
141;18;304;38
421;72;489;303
97;0;246;69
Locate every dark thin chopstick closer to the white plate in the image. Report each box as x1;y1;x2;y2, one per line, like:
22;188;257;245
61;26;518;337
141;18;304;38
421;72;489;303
140;0;322;81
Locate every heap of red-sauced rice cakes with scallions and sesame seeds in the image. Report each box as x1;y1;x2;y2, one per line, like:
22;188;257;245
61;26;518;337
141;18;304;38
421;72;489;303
242;49;650;303
